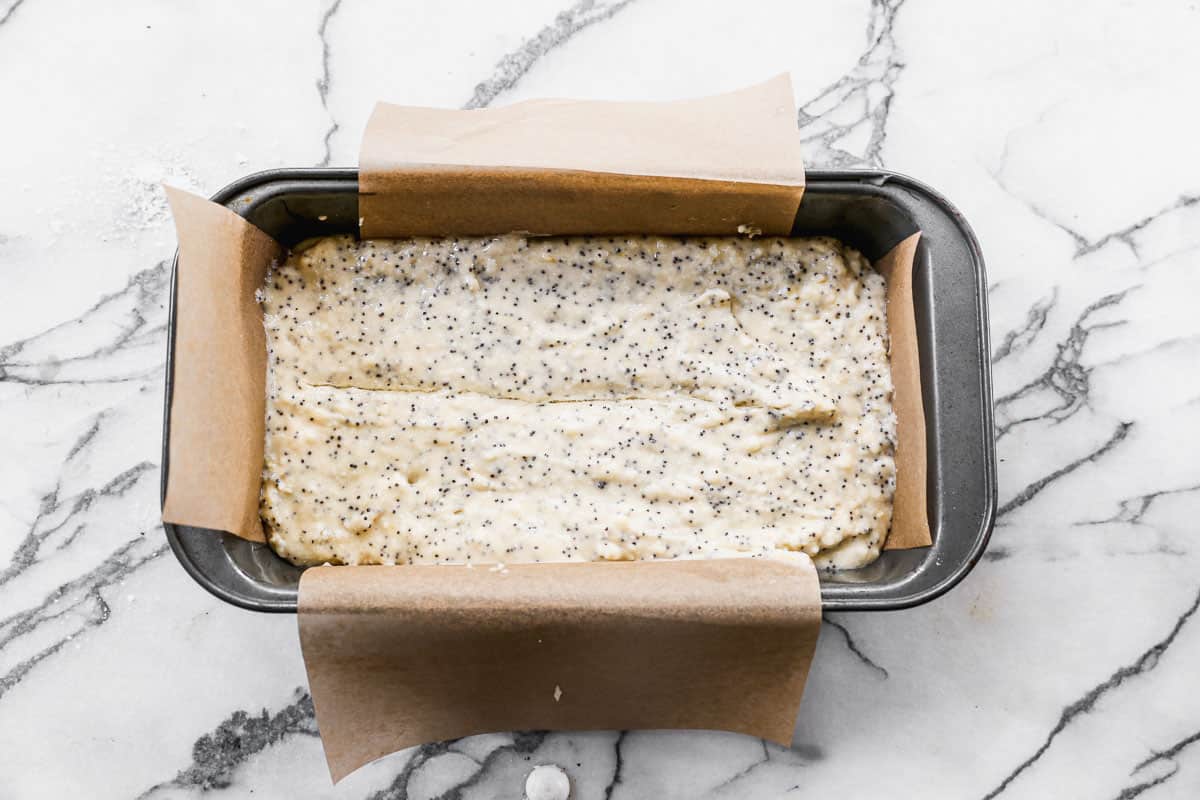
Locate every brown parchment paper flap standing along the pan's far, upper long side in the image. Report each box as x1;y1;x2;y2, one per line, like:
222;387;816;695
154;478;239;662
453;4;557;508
359;74;804;237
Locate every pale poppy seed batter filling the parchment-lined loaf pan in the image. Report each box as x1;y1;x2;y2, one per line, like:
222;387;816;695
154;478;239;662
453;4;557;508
262;236;895;569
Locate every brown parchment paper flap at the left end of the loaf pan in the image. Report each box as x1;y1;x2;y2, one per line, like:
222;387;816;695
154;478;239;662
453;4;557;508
162;186;282;542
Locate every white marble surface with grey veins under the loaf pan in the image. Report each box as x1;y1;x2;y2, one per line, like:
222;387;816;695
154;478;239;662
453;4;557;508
0;0;1200;800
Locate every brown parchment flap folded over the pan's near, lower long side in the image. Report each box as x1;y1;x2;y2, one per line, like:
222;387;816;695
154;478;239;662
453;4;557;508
300;559;821;781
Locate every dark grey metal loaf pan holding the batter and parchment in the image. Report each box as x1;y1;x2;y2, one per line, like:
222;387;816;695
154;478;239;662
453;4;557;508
162;169;996;612
